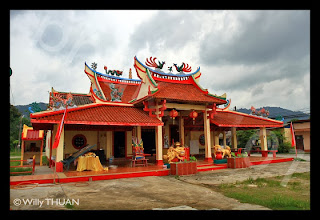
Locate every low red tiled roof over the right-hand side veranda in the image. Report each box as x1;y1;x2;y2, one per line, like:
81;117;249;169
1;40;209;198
211;111;283;128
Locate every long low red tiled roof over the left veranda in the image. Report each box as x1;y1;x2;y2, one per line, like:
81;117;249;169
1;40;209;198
31;104;163;126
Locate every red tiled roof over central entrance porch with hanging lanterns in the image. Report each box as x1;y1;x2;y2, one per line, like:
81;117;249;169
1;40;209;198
152;81;226;104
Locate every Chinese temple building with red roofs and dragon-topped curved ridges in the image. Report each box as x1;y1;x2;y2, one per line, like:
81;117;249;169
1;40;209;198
30;57;283;171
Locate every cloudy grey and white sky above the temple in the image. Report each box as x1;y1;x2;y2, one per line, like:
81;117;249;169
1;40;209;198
10;10;310;111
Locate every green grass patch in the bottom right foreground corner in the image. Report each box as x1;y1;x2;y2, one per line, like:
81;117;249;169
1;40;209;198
219;172;310;210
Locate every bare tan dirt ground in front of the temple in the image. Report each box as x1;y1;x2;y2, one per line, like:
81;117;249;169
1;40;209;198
10;156;310;210
